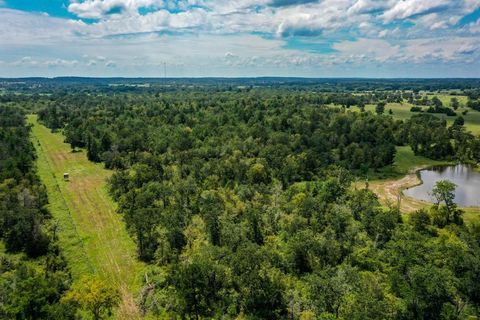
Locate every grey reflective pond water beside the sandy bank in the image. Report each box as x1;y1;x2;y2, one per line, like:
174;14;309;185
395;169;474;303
403;164;480;207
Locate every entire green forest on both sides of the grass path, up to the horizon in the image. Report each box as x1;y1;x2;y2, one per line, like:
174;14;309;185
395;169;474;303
0;78;480;320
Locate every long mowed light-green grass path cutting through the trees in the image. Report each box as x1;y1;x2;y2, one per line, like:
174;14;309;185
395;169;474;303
28;115;143;319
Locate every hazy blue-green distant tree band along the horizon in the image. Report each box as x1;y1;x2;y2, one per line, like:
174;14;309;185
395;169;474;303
0;77;480;95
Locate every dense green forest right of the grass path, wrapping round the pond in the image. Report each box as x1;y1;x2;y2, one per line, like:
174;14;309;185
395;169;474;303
20;89;480;319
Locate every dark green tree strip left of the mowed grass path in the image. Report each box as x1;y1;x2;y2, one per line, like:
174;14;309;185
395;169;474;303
0;106;76;319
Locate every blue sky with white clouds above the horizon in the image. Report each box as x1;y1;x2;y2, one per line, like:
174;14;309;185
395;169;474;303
0;0;480;77
